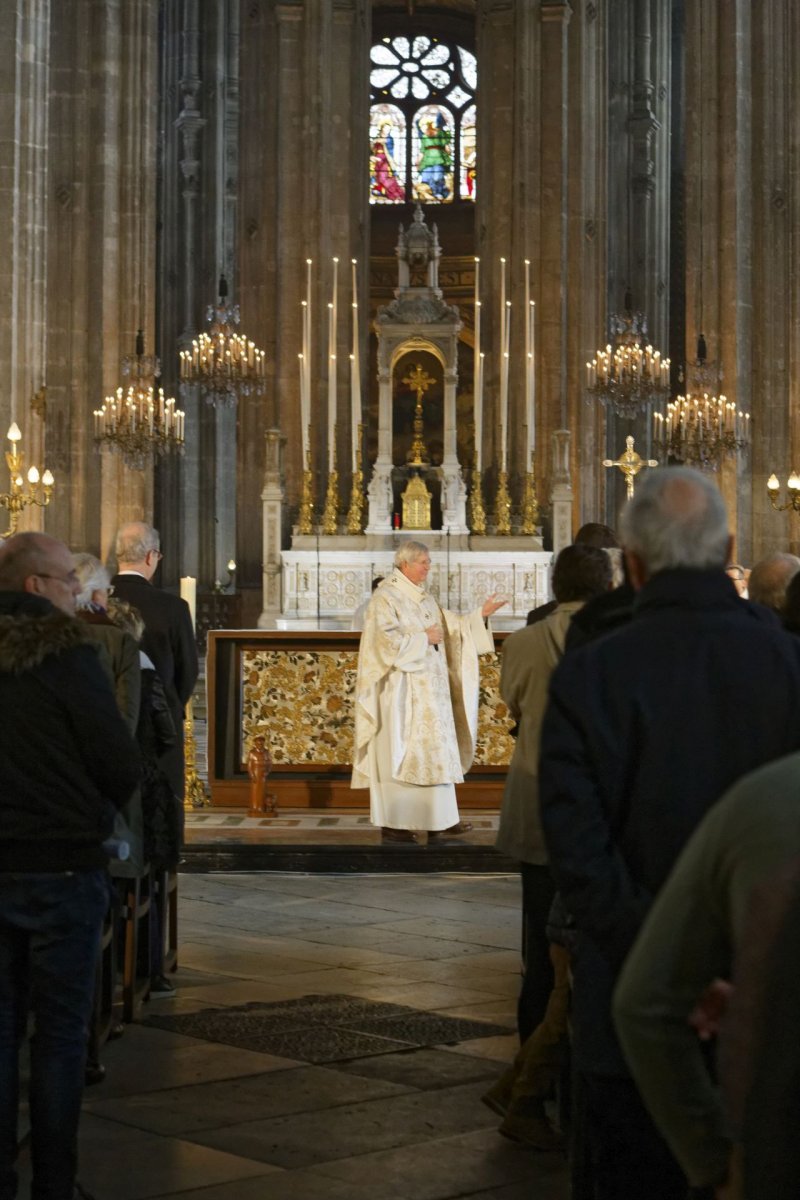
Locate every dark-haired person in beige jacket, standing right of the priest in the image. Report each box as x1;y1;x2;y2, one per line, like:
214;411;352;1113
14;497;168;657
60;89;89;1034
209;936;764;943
485;544;612;1148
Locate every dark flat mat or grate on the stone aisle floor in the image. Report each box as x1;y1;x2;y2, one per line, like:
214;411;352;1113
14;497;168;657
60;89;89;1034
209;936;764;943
144;996;513;1063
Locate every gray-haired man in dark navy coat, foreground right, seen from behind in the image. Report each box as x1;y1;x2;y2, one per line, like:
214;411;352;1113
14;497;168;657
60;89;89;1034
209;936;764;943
540;467;800;1200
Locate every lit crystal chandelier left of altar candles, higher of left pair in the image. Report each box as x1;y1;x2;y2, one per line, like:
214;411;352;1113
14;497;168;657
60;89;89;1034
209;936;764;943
181;275;265;407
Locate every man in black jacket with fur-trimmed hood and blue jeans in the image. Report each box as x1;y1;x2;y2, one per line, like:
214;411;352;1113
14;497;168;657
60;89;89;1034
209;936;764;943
0;533;139;1200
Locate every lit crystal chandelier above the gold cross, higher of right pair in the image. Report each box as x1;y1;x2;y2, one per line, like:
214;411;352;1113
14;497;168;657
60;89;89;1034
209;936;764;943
587;302;669;418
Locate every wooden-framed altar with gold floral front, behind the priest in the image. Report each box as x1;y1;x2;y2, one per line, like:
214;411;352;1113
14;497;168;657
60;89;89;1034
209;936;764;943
206;630;513;808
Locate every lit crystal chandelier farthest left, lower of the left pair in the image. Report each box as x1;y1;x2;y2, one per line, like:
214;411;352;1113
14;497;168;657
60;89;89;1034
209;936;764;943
95;330;184;470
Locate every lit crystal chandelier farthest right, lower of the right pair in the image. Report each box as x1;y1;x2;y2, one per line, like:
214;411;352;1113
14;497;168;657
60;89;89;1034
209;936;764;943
652;392;750;470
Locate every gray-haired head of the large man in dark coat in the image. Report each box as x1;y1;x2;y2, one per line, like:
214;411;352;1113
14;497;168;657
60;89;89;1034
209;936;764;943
620;467;729;578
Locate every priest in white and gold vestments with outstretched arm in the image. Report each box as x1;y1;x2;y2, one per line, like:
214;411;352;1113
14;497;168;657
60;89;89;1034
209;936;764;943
351;541;505;841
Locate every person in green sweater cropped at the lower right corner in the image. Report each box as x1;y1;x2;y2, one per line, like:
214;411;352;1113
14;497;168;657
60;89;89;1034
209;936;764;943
614;754;800;1200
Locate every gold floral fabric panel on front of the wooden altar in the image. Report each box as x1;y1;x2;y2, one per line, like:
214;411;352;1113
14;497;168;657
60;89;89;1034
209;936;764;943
241;649;513;767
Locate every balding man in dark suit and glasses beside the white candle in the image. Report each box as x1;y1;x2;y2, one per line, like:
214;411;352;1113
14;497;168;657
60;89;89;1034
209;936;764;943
112;521;198;804
